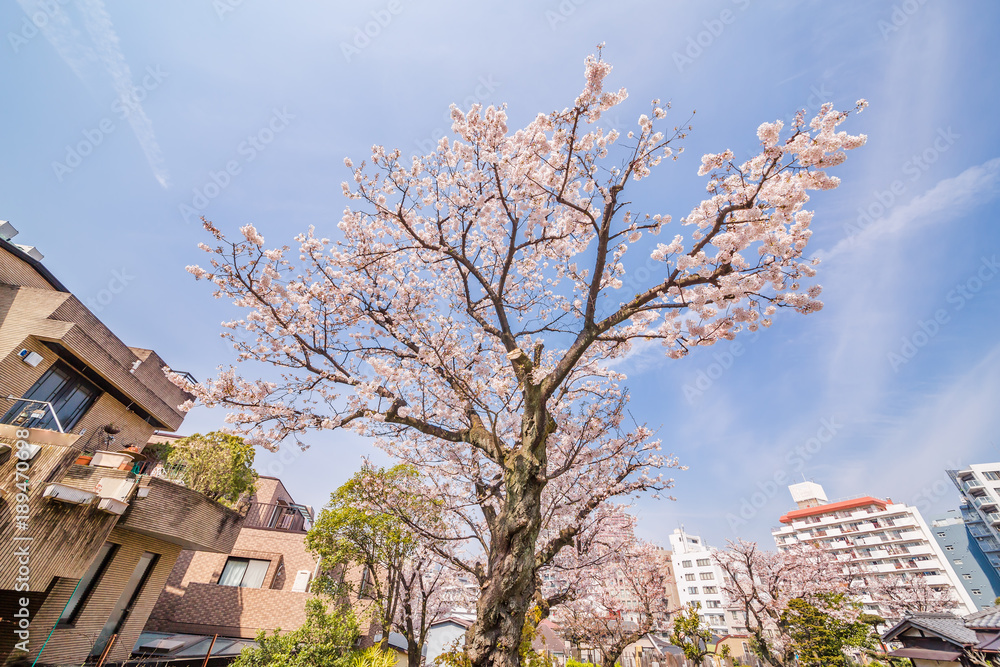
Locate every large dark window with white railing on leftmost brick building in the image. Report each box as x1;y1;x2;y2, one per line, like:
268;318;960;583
0;361;101;432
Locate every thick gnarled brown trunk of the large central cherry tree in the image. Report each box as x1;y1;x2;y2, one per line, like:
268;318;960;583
466;420;546;667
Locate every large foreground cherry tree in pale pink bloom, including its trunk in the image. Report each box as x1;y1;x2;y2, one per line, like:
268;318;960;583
175;49;865;667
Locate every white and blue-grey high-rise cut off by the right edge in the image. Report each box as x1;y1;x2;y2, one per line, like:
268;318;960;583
948;462;1000;574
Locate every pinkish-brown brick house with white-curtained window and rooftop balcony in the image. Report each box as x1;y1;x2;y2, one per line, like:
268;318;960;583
144;477;317;639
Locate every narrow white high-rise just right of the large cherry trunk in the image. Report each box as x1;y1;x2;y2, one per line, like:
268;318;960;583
670;528;729;635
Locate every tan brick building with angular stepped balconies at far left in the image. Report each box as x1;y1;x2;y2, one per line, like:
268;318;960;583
0;223;242;665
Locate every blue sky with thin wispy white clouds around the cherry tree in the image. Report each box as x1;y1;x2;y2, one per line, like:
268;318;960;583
0;0;1000;544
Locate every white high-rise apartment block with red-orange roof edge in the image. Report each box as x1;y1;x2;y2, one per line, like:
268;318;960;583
771;482;977;615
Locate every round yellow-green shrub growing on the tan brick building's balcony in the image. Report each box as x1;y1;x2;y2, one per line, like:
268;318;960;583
161;431;257;506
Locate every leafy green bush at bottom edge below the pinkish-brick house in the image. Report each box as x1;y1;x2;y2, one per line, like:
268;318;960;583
232;598;364;667
